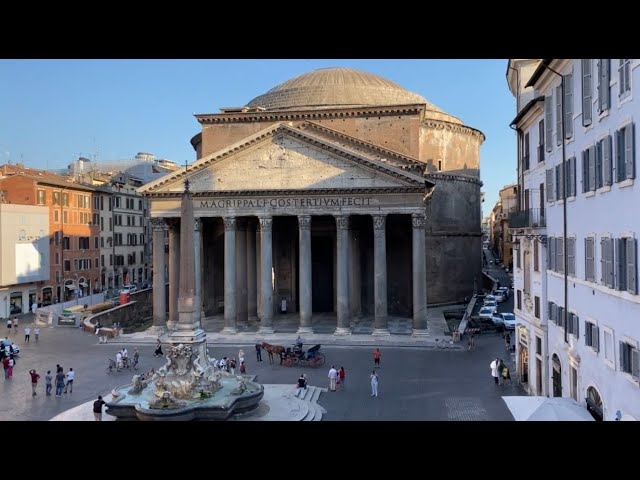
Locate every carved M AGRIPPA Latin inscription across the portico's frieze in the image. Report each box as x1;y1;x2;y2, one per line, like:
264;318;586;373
195;197;371;210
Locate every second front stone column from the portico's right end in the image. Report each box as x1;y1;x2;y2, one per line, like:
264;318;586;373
372;215;389;335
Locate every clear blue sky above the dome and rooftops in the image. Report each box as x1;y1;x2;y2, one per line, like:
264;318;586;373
0;59;516;215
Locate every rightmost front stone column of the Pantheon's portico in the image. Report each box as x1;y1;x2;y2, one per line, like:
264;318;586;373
411;213;428;336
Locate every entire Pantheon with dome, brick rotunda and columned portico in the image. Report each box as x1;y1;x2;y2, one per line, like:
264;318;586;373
140;68;484;335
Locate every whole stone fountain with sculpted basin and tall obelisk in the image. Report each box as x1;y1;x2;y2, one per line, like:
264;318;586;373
106;172;264;421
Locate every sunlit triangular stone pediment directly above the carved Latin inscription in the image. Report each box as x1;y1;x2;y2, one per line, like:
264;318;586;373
139;124;425;193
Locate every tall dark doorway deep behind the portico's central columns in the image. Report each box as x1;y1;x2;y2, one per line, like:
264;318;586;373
311;235;334;313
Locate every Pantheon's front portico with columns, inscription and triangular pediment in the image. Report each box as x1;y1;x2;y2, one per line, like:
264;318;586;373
142;124;433;335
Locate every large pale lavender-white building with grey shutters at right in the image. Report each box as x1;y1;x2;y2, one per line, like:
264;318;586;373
514;59;640;420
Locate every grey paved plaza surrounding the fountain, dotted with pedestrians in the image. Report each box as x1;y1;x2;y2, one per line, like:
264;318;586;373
0;314;522;421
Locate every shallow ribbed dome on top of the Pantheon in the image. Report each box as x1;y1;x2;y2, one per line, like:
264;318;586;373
247;68;456;119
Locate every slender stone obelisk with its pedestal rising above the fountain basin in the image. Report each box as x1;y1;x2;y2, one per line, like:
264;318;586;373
167;180;207;354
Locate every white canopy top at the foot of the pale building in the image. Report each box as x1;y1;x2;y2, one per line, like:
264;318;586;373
502;396;595;422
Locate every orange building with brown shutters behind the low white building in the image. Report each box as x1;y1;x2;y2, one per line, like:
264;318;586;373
0;164;101;305
